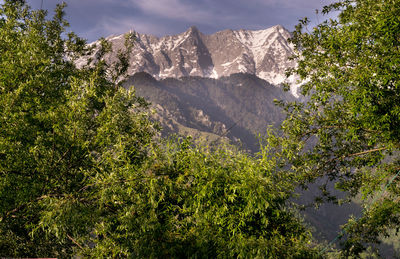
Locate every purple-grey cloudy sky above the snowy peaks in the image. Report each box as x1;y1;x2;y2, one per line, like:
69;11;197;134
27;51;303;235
24;0;333;42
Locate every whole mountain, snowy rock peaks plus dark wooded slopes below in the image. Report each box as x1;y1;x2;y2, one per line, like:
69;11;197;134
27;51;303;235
76;25;298;151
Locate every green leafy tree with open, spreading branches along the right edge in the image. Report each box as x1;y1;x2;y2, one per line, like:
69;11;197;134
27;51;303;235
281;0;400;255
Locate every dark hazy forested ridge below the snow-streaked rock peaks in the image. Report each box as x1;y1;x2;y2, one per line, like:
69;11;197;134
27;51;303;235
125;72;294;152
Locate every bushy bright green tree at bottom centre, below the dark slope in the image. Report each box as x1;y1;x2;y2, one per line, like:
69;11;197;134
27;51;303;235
74;140;319;258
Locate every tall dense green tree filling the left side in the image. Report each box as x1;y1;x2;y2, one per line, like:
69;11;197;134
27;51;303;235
0;1;155;257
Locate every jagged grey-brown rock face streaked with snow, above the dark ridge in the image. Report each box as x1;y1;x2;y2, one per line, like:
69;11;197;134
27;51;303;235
98;25;296;95
